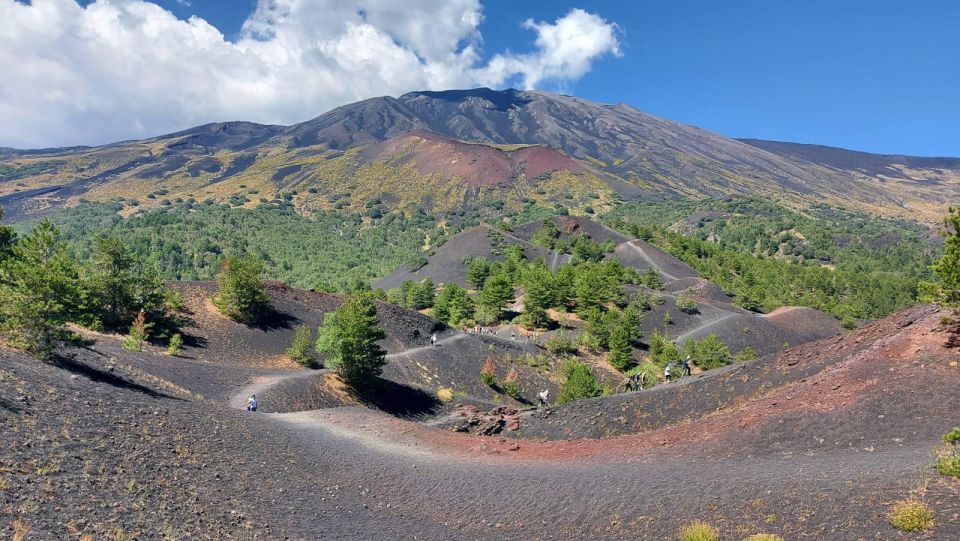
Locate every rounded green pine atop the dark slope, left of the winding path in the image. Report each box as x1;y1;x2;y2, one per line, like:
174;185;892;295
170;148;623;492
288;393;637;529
213;256;270;324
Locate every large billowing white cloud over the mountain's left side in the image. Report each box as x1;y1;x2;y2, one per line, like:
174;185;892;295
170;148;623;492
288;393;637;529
0;0;620;148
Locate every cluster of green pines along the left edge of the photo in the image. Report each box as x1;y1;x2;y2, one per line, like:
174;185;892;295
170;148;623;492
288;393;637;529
0;213;181;360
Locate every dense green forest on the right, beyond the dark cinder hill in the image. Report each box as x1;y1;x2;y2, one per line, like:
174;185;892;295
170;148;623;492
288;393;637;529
605;198;940;327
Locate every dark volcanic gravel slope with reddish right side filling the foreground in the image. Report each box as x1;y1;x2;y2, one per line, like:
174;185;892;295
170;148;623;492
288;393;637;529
0;307;960;540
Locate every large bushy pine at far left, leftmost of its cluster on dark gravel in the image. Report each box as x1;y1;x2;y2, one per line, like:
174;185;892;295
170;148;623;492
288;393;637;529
0;220;79;360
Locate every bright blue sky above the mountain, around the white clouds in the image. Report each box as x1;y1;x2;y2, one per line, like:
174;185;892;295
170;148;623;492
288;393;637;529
13;0;960;156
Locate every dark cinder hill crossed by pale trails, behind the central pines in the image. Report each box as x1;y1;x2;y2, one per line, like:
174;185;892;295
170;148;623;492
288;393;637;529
374;216;843;355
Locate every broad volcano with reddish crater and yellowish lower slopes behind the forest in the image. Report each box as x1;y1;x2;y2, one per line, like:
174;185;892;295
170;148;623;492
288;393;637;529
0;88;960;223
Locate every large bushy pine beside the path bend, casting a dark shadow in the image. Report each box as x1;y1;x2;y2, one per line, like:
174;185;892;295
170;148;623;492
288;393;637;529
317;292;387;386
